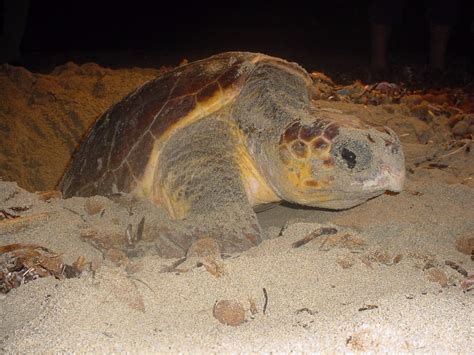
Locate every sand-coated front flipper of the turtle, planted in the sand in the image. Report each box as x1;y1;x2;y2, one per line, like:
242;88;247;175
153;117;261;253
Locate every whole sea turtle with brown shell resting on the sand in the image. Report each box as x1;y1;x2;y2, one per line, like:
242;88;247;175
60;52;405;255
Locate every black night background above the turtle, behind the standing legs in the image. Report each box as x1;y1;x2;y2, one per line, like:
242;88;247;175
2;0;474;79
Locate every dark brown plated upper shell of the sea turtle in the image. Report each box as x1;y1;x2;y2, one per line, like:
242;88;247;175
59;52;310;197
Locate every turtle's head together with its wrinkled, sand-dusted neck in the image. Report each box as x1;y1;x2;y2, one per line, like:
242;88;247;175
232;65;405;209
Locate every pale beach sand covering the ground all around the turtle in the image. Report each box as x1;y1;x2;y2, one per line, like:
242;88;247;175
0;64;474;353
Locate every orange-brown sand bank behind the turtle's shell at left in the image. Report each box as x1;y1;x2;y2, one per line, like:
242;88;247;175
0;63;166;191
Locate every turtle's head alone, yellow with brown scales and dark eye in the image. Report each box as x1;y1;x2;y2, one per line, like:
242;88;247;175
268;114;405;209
